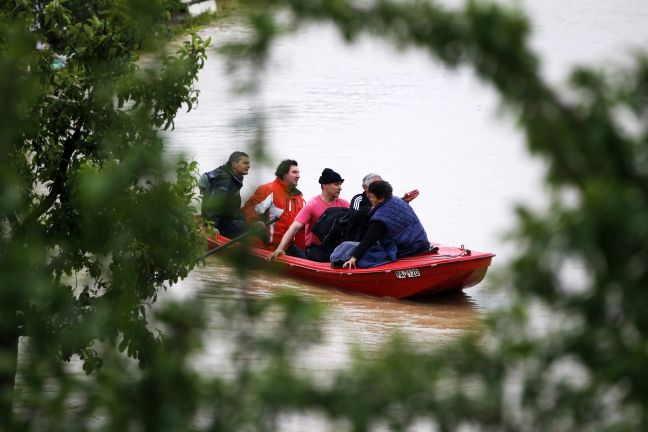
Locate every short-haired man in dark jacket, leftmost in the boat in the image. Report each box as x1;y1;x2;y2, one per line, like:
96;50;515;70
198;151;250;237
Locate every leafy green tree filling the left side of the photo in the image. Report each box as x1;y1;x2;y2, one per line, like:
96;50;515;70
0;0;209;430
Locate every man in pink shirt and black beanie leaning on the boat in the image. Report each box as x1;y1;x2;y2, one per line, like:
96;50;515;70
268;168;349;262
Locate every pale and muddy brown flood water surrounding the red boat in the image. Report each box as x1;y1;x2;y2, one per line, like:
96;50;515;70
161;0;648;371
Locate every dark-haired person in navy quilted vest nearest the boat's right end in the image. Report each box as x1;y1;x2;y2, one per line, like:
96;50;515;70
343;180;430;268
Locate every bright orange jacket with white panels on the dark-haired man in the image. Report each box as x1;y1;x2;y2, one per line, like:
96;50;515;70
243;177;306;250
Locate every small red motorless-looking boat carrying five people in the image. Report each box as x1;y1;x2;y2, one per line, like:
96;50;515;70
209;236;495;299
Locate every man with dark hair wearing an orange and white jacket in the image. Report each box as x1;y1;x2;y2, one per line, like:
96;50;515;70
243;159;306;258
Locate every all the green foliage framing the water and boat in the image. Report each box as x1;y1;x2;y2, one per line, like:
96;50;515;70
0;0;648;431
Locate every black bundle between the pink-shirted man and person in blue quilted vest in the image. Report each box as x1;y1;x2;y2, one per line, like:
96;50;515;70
311;207;369;252
